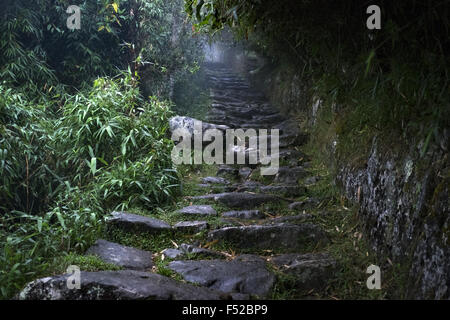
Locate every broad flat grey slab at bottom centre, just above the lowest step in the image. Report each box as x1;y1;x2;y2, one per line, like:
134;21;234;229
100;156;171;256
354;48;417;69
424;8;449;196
169;255;275;297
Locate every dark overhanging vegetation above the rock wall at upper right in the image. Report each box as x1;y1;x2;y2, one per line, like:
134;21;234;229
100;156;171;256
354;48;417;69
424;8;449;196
185;0;450;160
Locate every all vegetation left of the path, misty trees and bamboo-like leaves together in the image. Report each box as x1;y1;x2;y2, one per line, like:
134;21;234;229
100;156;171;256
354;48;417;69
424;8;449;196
0;0;200;298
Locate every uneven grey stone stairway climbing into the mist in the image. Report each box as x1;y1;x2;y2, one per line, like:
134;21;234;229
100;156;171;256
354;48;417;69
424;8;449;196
19;65;336;299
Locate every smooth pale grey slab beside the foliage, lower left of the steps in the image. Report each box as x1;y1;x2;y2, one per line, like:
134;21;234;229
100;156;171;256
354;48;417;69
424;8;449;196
86;239;153;270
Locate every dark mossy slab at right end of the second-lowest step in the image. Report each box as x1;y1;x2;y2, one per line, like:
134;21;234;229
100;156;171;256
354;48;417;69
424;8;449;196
270;253;336;291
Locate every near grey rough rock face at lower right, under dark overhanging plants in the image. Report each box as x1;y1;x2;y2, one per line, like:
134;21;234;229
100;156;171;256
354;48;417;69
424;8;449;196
336;141;450;299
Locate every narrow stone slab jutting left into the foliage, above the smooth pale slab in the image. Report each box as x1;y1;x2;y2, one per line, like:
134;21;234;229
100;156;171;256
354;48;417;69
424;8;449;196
108;212;172;233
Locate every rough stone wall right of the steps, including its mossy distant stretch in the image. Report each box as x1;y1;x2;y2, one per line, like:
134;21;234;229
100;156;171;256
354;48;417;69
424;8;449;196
243;53;450;299
